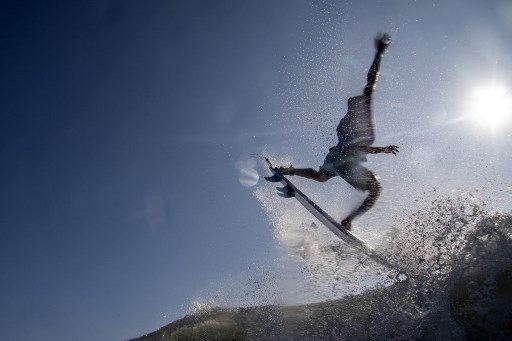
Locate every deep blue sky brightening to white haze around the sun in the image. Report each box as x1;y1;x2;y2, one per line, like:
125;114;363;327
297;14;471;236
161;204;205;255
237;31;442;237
0;0;512;340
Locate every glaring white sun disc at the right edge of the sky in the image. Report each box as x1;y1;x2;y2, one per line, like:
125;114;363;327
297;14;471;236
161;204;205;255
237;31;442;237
467;84;512;130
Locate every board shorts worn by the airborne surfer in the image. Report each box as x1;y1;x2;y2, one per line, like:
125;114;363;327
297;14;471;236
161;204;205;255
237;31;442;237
320;148;375;191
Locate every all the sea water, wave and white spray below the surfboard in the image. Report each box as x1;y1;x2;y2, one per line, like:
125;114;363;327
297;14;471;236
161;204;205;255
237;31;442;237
133;193;512;340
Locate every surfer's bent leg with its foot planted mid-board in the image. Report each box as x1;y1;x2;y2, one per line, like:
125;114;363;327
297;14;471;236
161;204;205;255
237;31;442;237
341;165;382;230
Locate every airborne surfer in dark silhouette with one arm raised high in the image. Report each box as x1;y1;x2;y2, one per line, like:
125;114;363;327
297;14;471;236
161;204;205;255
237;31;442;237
278;33;398;230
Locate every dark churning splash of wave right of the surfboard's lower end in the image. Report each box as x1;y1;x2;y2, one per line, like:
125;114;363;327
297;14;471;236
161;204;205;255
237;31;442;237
377;194;512;339
